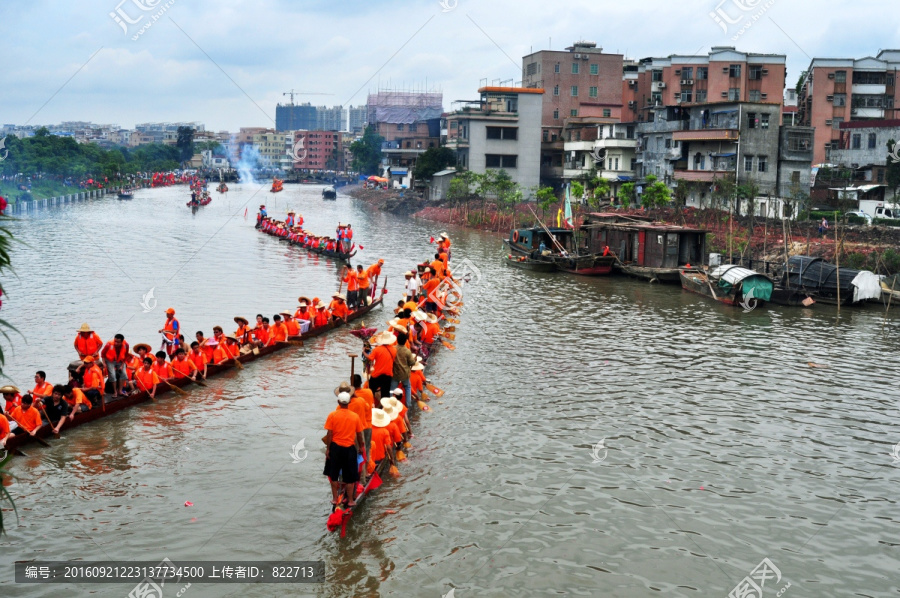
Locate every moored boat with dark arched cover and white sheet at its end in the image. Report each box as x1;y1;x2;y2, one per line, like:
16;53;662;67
777;255;882;305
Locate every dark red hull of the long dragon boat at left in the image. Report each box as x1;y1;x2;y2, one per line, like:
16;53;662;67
6;296;387;453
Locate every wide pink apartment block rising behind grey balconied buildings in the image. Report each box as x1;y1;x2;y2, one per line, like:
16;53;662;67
621;46;787;122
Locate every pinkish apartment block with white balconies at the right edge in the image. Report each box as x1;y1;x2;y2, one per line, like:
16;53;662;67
798;50;900;164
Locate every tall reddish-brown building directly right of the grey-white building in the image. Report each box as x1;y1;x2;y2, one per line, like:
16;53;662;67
522;41;623;185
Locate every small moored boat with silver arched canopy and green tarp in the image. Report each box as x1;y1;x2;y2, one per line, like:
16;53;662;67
681;265;774;311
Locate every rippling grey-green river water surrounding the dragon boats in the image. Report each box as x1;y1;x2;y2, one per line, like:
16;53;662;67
0;185;900;598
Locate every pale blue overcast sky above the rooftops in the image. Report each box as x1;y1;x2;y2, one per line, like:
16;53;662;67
0;0;900;131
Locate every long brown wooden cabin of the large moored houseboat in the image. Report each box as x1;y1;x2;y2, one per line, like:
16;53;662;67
581;213;706;268
